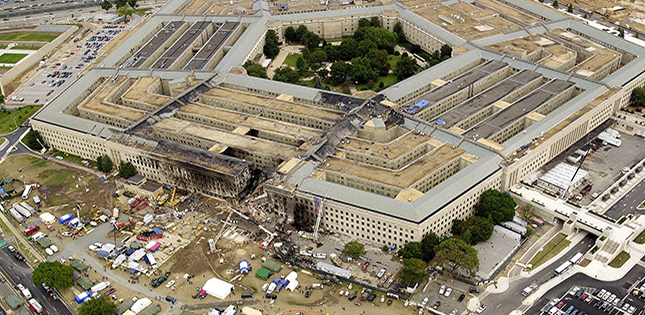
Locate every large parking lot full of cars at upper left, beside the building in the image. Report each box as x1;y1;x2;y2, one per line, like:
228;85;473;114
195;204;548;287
9;25;123;104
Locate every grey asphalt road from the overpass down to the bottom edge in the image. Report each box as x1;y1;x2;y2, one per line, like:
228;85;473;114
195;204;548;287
482;234;596;314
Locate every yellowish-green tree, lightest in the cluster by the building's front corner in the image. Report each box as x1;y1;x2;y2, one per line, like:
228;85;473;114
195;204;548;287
436;237;479;275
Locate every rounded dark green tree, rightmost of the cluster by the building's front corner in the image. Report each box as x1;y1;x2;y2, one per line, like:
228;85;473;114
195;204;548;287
475;189;517;224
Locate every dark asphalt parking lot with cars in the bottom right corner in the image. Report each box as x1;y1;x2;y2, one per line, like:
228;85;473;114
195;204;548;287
525;258;645;315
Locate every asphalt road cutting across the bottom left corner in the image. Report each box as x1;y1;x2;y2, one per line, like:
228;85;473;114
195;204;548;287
0;247;73;315
